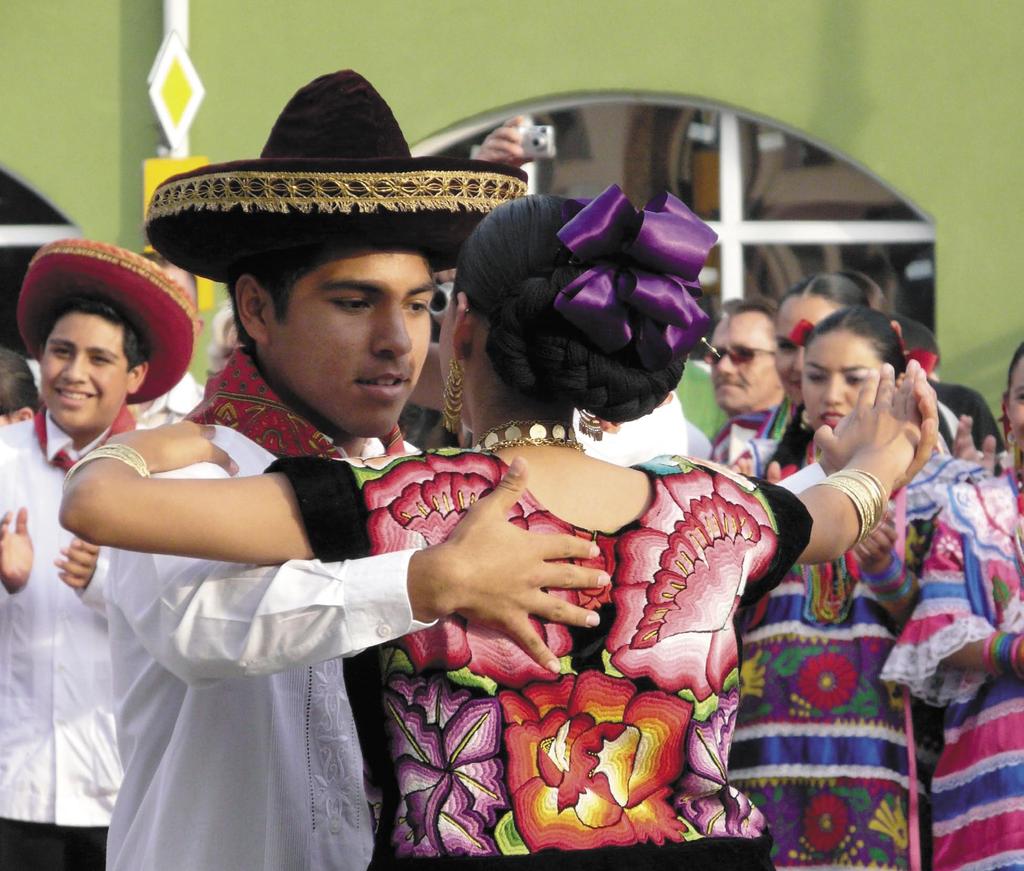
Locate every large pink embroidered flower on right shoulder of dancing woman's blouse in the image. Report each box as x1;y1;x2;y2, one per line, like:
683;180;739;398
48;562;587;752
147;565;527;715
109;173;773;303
608;470;776;699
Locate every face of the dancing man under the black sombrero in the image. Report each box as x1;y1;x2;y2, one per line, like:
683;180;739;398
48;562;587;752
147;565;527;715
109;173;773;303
256;251;434;451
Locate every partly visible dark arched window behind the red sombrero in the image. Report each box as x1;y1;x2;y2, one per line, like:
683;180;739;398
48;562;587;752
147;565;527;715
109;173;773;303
0;169;82;352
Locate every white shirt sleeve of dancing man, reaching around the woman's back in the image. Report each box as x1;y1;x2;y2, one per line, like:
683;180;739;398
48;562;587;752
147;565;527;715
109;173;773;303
112;551;423;685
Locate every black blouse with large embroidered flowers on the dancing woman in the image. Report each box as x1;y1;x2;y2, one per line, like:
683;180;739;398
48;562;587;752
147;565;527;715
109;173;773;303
271;451;810;871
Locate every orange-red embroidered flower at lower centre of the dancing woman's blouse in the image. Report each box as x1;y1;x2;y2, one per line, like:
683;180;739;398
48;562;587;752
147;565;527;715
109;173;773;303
499;671;691;852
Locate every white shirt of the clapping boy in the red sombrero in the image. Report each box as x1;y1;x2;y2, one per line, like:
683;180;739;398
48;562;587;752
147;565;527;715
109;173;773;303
0;416;121;826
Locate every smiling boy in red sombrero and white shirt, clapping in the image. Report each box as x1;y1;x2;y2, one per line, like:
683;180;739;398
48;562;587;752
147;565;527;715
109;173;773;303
0;239;195;871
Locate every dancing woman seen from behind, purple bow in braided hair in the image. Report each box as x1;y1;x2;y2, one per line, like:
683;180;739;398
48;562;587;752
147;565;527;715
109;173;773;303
62;187;936;869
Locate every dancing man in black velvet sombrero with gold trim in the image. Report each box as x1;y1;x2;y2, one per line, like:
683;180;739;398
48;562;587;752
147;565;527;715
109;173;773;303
101;71;595;871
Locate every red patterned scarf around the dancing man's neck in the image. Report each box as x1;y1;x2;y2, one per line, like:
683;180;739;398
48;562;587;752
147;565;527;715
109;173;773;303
188;348;404;460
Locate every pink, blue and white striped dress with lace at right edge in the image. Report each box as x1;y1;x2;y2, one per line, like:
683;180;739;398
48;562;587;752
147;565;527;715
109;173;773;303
883;476;1024;871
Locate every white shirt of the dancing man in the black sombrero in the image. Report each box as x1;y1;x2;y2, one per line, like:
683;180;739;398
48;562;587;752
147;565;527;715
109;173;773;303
108;427;423;871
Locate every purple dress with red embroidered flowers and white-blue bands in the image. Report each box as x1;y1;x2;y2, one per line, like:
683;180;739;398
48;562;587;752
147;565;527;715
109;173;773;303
730;451;974;869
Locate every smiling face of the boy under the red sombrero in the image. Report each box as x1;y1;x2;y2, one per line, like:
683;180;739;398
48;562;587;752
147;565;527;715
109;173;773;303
39;311;146;448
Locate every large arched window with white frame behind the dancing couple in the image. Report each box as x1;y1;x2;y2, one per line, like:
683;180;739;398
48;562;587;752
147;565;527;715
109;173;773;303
414;95;935;326
